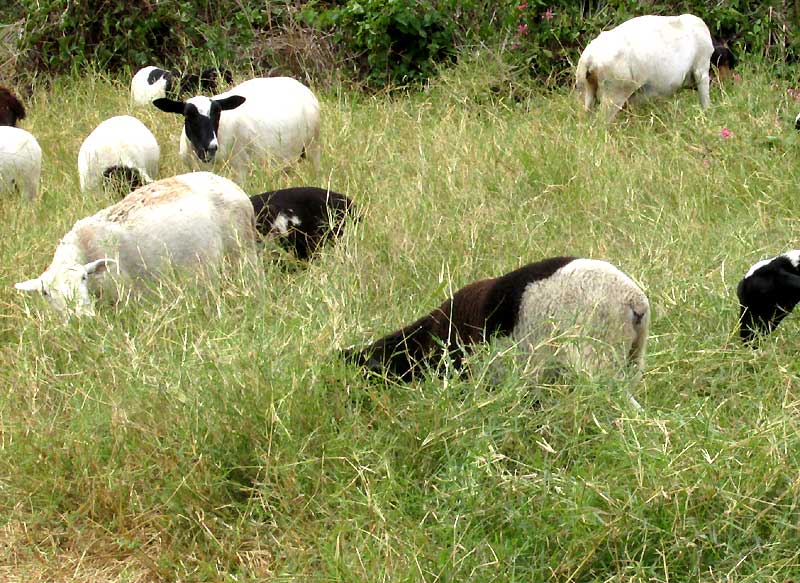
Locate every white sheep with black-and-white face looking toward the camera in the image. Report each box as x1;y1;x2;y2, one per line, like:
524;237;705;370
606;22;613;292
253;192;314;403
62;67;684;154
153;77;320;182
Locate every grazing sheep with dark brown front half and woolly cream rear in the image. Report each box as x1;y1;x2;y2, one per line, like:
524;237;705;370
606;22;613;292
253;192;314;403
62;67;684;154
344;257;650;381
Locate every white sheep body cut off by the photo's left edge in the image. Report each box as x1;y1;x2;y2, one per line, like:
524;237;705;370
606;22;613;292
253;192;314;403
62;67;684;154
0;126;42;200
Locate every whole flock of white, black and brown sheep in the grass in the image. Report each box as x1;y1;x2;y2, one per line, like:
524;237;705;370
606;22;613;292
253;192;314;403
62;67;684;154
0;14;800;380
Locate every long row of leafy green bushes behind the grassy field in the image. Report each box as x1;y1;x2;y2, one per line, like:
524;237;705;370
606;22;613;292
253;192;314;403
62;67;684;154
6;0;800;88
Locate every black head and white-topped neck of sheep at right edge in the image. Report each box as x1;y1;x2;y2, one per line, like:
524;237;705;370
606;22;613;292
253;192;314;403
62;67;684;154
736;250;800;344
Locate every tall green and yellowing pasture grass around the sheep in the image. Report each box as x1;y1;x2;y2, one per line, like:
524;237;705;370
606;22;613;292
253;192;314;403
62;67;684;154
0;61;800;582
